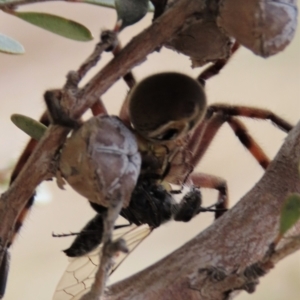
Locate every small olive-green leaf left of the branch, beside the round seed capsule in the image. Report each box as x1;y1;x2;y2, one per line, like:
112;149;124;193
10;114;47;141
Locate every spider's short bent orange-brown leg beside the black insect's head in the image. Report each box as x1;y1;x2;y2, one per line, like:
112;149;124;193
188;173;229;219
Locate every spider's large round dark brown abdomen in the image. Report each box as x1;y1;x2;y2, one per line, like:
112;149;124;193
129;73;206;143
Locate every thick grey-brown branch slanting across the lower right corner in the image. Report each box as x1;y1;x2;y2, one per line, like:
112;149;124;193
105;122;300;300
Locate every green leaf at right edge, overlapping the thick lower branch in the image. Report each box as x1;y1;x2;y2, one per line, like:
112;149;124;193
279;194;300;235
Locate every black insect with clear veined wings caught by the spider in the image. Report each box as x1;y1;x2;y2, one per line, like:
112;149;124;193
53;179;220;300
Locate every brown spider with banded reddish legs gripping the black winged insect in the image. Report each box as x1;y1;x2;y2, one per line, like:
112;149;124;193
1;44;292;298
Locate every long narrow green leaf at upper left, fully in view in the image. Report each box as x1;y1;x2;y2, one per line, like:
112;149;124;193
14;12;93;42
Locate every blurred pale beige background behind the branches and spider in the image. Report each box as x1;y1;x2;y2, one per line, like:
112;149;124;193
0;3;300;300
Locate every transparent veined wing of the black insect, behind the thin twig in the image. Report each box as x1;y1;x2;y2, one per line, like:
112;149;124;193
52;225;152;300
